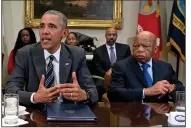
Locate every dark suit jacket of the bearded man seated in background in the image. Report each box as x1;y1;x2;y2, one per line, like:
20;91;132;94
93;43;131;77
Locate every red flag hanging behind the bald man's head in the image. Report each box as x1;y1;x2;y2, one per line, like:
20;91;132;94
137;0;162;59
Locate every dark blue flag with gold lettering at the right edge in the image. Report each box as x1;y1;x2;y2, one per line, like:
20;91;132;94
167;0;185;62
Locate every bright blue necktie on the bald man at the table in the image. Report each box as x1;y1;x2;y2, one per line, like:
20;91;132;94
142;64;153;87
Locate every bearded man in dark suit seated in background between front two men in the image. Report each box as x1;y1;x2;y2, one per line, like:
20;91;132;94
93;28;131;99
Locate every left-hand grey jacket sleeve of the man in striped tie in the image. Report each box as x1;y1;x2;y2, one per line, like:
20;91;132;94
5;50;32;105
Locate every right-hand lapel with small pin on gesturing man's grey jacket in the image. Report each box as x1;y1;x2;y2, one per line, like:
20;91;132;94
59;44;72;84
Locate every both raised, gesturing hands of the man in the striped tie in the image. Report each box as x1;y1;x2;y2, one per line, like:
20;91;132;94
33;72;87;103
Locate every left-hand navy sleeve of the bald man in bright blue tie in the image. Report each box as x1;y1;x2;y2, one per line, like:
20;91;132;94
107;63;143;102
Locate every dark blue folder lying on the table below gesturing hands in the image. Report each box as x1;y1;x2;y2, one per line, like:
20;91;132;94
46;103;97;121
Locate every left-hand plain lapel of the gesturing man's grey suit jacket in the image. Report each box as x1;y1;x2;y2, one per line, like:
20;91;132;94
31;44;46;80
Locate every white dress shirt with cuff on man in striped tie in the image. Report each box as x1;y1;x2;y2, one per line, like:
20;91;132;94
30;45;61;103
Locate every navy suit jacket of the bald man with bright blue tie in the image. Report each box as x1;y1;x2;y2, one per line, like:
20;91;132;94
108;56;185;102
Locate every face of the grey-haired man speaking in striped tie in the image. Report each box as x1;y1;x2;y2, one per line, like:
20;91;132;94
40;14;65;53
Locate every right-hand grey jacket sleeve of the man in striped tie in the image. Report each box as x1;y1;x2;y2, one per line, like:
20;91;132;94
77;50;98;104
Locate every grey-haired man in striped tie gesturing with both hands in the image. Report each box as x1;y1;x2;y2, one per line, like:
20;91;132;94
6;10;98;106
